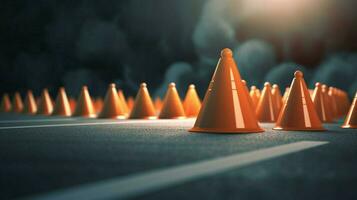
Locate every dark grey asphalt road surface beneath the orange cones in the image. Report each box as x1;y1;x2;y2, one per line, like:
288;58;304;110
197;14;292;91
0;114;357;200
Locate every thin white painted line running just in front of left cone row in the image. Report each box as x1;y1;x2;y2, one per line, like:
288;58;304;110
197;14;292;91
0;120;193;130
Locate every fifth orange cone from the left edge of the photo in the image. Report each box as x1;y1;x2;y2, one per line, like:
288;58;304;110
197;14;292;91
52;87;72;117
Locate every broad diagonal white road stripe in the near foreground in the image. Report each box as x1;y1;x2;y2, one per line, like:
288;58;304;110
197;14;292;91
28;141;328;200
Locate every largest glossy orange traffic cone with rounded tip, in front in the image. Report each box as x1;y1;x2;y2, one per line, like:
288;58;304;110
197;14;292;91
189;48;264;133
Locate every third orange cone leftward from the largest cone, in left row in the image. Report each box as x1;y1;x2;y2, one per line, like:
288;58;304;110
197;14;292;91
129;83;157;119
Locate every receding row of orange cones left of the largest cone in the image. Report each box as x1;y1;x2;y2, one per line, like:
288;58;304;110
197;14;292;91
1;83;201;119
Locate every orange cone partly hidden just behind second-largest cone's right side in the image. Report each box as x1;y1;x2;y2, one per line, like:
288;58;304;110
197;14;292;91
312;82;333;123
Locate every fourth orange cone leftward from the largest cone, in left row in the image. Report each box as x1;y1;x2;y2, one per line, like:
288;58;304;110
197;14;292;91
99;83;126;119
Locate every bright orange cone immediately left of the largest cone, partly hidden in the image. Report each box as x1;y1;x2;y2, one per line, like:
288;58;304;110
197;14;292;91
183;84;201;117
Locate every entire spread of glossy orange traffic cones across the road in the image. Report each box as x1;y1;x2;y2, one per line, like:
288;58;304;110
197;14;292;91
1;49;356;133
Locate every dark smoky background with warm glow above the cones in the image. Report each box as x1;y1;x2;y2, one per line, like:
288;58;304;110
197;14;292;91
0;0;357;98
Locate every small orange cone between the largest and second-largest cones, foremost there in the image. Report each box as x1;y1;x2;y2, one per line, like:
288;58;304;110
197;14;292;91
256;82;279;122
